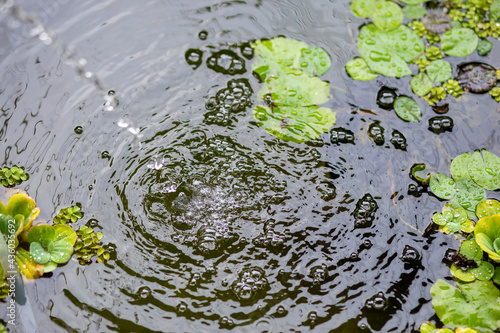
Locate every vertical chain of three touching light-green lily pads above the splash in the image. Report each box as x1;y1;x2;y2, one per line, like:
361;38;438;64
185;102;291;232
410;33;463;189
252;37;336;143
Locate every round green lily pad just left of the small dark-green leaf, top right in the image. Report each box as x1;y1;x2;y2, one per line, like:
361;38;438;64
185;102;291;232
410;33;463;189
441;28;479;57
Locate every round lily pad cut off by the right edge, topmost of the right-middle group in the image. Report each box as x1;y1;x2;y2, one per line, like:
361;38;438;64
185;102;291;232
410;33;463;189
469;149;500;191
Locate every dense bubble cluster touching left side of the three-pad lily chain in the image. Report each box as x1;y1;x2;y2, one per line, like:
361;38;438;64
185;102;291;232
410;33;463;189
205;79;253;125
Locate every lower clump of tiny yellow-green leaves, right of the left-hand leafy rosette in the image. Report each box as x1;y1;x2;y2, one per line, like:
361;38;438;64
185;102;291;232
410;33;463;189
75;226;110;265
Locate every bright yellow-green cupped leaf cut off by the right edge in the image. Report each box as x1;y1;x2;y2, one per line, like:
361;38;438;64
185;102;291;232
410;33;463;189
474;214;500;263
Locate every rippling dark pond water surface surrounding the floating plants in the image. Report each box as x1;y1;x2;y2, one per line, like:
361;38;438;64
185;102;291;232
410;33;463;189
0;0;500;332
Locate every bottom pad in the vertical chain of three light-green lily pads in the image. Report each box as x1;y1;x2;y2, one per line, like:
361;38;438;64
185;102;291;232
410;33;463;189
254;105;335;143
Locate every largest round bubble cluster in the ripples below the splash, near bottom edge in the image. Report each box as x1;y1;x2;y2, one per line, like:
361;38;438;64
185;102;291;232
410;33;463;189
232;267;269;302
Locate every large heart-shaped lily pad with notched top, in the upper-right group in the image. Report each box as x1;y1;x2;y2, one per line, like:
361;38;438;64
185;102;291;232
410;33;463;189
357;24;424;77
